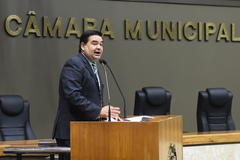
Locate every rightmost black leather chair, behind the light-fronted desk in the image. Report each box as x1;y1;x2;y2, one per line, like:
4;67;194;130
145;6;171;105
197;88;235;132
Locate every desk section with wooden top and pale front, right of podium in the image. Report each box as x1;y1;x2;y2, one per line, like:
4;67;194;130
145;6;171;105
183;130;240;160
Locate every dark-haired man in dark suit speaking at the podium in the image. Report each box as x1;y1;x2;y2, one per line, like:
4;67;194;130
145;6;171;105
52;30;121;159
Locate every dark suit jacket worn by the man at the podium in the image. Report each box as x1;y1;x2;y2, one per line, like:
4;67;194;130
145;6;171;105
52;53;102;140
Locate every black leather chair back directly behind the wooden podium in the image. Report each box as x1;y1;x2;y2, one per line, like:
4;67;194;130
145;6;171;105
134;87;172;115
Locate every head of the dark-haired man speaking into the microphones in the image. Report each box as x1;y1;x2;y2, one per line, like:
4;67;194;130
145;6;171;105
79;30;103;62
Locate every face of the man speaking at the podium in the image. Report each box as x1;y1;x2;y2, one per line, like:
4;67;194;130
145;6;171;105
81;35;103;62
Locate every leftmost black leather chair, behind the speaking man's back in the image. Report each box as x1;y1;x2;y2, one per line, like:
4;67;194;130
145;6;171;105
0;95;36;141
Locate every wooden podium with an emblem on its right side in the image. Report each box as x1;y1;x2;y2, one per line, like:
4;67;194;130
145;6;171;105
71;116;183;160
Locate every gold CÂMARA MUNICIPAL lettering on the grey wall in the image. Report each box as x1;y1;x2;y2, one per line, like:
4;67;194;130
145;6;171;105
4;11;240;42
